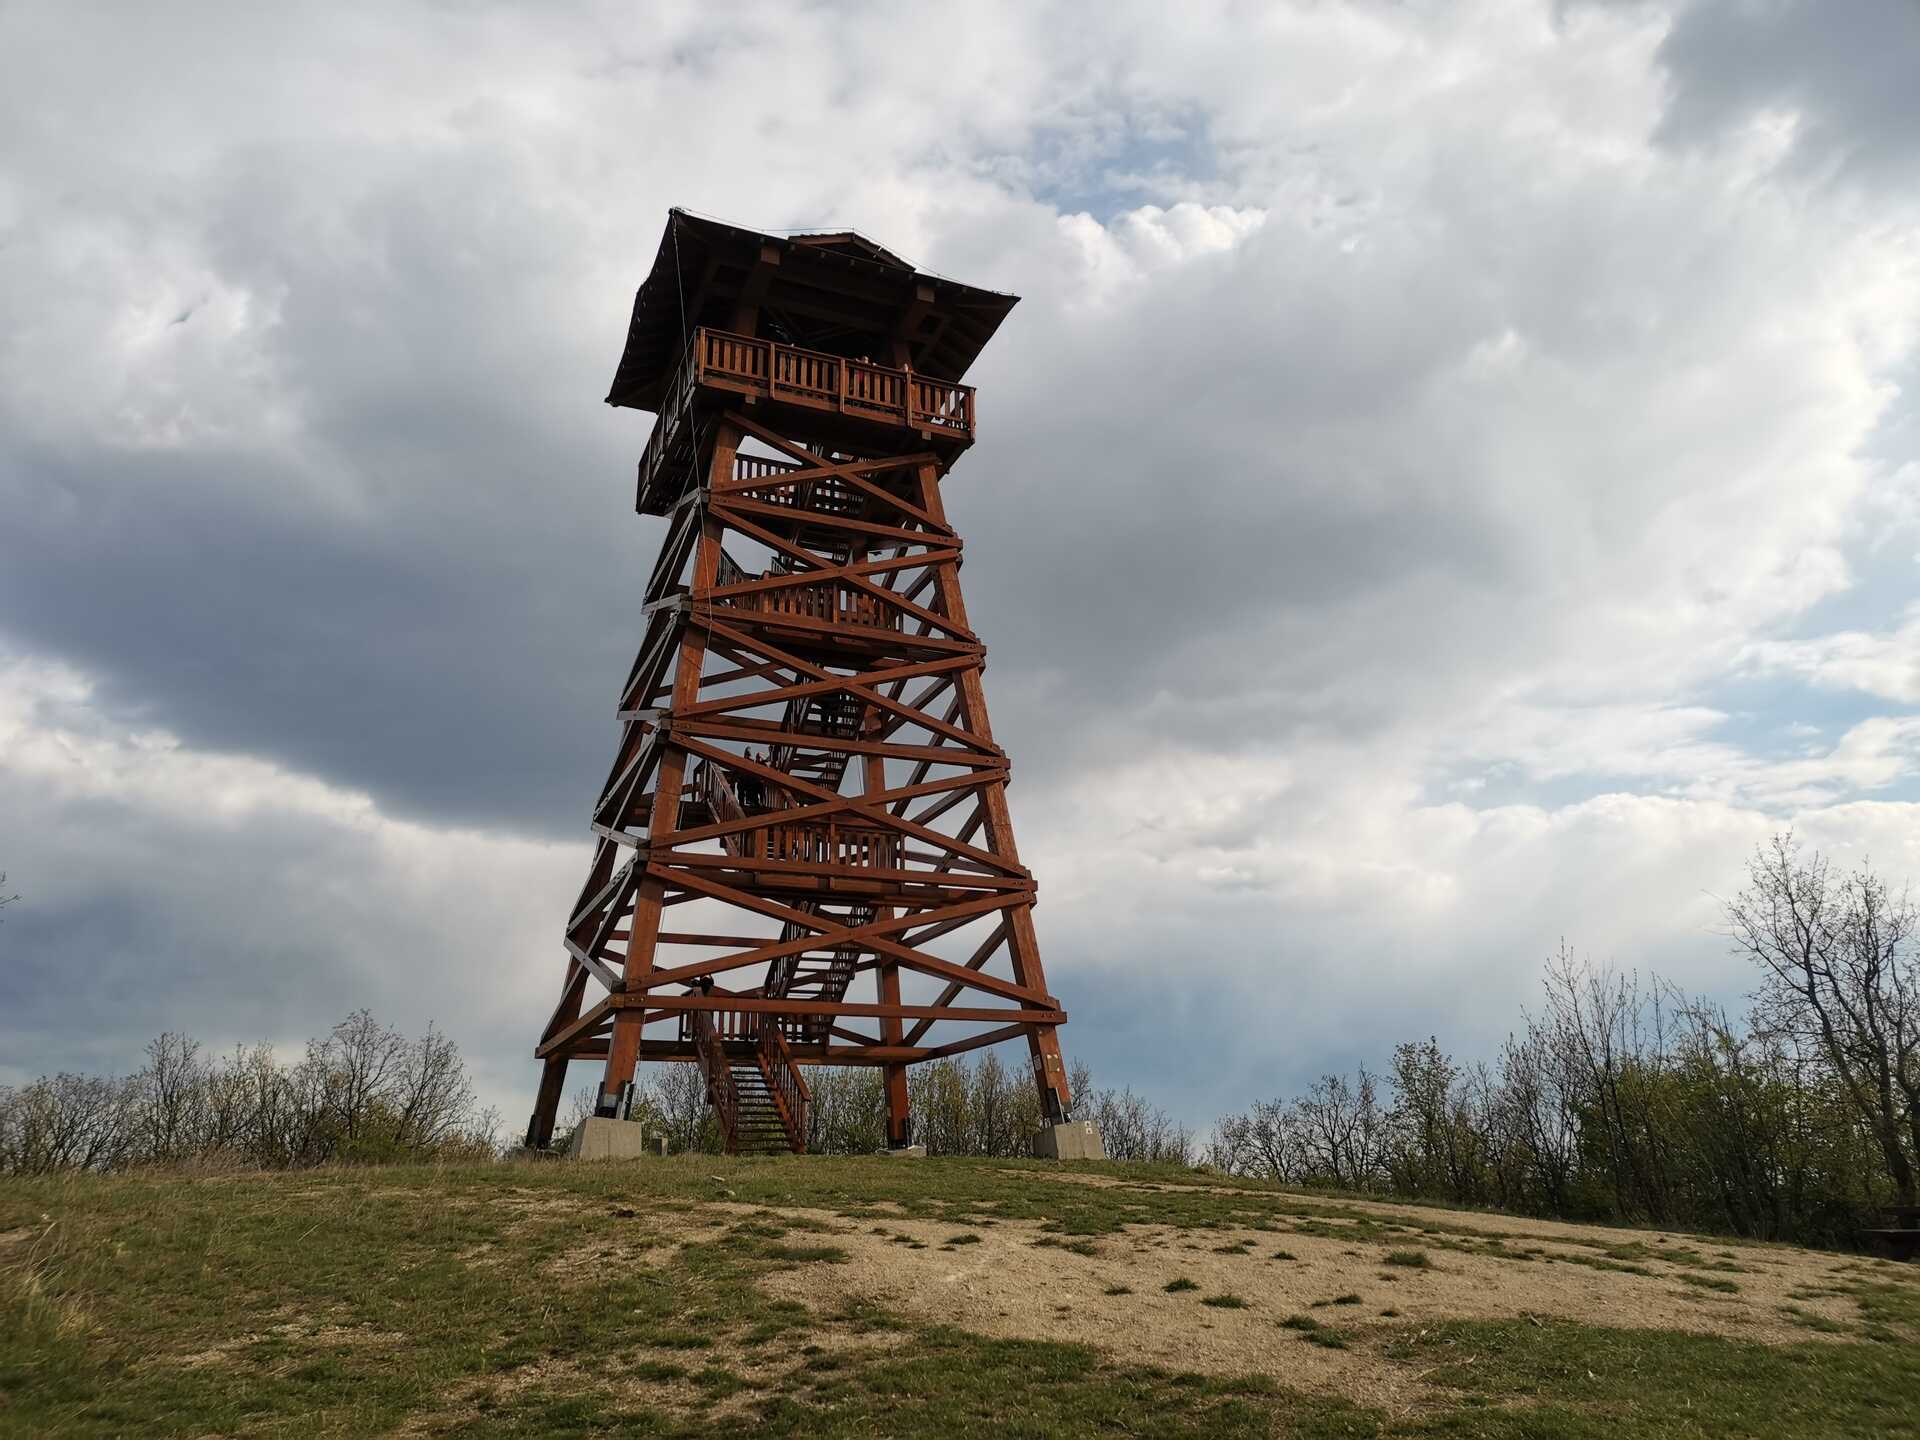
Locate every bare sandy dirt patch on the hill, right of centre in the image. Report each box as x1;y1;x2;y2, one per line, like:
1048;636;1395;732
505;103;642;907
744;1177;1889;1409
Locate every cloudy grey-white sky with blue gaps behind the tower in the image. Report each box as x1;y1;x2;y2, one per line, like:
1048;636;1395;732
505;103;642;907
0;0;1920;1123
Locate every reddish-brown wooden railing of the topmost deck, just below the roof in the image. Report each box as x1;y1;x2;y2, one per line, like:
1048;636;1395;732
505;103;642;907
691;326;973;440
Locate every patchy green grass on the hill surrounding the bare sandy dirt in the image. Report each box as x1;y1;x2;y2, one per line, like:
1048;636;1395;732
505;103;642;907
0;1156;1920;1440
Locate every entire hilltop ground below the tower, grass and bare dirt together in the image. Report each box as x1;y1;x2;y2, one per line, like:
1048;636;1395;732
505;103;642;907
0;1156;1920;1440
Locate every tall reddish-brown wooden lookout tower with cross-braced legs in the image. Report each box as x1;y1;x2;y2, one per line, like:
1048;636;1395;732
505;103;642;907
528;209;1069;1152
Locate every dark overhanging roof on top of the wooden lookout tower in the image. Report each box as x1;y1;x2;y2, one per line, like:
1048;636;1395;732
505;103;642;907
607;209;1020;409
